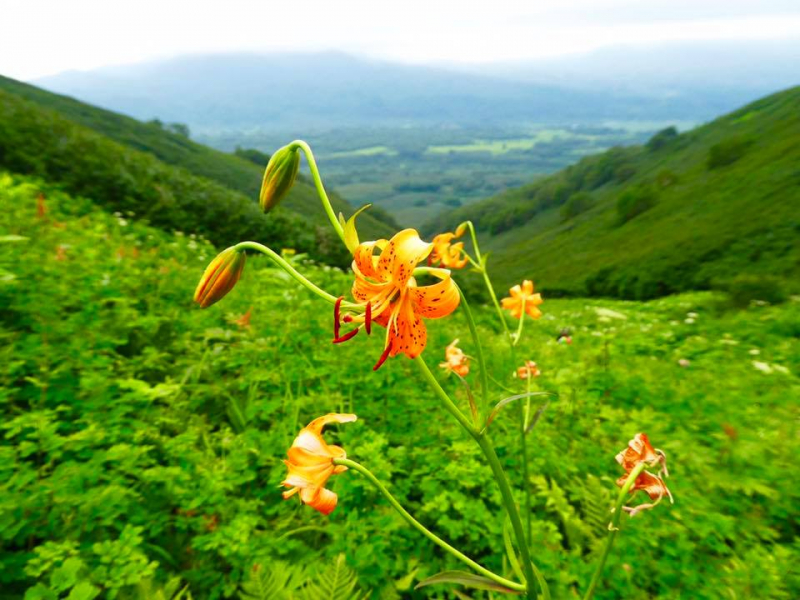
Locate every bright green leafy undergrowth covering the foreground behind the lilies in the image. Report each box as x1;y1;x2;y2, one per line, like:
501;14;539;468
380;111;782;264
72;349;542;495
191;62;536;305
0;175;800;600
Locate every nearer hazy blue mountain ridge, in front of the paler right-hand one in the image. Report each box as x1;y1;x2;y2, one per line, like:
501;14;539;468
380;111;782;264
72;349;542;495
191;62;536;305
31;47;788;132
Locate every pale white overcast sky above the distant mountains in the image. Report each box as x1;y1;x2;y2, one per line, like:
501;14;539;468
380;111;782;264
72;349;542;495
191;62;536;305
6;0;800;79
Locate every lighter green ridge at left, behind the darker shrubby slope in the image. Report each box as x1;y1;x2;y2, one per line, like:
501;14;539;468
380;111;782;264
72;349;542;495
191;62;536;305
0;76;394;237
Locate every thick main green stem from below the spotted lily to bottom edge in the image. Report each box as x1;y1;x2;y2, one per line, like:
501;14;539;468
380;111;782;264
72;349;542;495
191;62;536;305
414;356;549;593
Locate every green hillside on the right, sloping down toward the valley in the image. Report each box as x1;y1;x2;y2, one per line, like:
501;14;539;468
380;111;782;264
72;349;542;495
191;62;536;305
424;88;800;299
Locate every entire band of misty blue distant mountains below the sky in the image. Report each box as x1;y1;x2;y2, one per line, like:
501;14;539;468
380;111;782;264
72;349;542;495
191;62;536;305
35;43;800;133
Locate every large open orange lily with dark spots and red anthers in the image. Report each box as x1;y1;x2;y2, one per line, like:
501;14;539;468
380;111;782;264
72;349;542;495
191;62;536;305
333;229;460;369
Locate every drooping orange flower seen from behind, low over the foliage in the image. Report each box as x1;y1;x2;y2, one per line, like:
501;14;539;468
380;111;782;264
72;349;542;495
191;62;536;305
281;413;356;515
